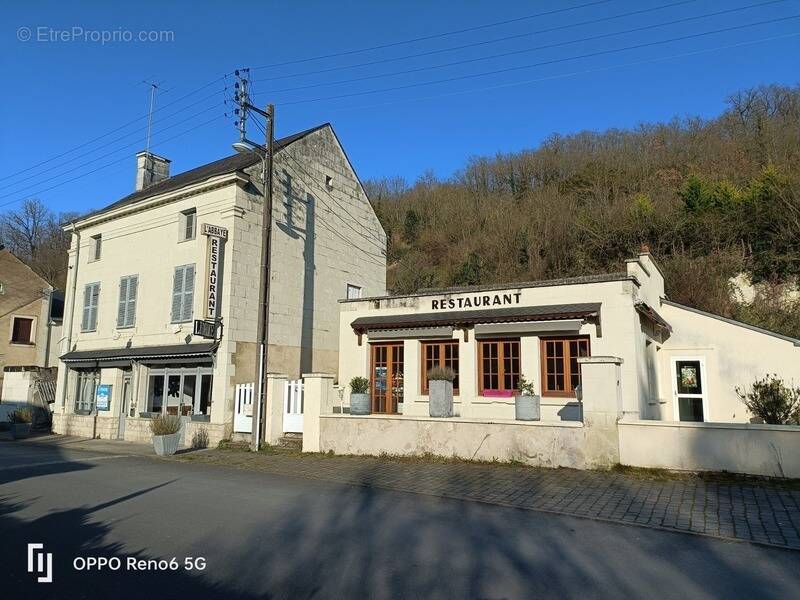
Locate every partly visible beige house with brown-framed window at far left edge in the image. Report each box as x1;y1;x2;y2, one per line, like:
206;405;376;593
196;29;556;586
0;246;64;402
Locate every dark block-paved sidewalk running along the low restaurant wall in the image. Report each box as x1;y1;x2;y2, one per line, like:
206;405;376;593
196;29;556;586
175;450;800;550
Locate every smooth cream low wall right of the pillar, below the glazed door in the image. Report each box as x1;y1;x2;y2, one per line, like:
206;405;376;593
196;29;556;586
619;421;800;478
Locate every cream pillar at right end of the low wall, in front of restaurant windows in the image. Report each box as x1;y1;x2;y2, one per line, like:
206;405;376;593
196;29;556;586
578;356;623;468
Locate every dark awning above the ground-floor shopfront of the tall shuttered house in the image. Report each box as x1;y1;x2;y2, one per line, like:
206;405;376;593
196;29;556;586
61;342;214;368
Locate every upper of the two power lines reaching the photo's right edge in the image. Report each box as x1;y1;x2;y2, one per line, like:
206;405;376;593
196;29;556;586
280;14;800;106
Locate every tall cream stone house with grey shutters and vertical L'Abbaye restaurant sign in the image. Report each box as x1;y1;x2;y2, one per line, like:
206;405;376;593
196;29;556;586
53;124;386;443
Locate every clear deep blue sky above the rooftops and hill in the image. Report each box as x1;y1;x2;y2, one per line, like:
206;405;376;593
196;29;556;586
0;0;800;218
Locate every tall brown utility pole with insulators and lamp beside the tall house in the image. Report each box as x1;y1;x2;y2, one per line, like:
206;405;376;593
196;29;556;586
233;69;275;452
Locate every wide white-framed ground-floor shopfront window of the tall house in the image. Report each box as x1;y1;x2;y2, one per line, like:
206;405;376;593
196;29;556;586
147;367;213;417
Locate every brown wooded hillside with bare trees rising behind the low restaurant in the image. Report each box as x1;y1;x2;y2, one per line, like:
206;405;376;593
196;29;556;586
365;86;800;337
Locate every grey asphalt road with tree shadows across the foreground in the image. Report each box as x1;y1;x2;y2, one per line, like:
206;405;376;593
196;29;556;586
0;442;800;600
